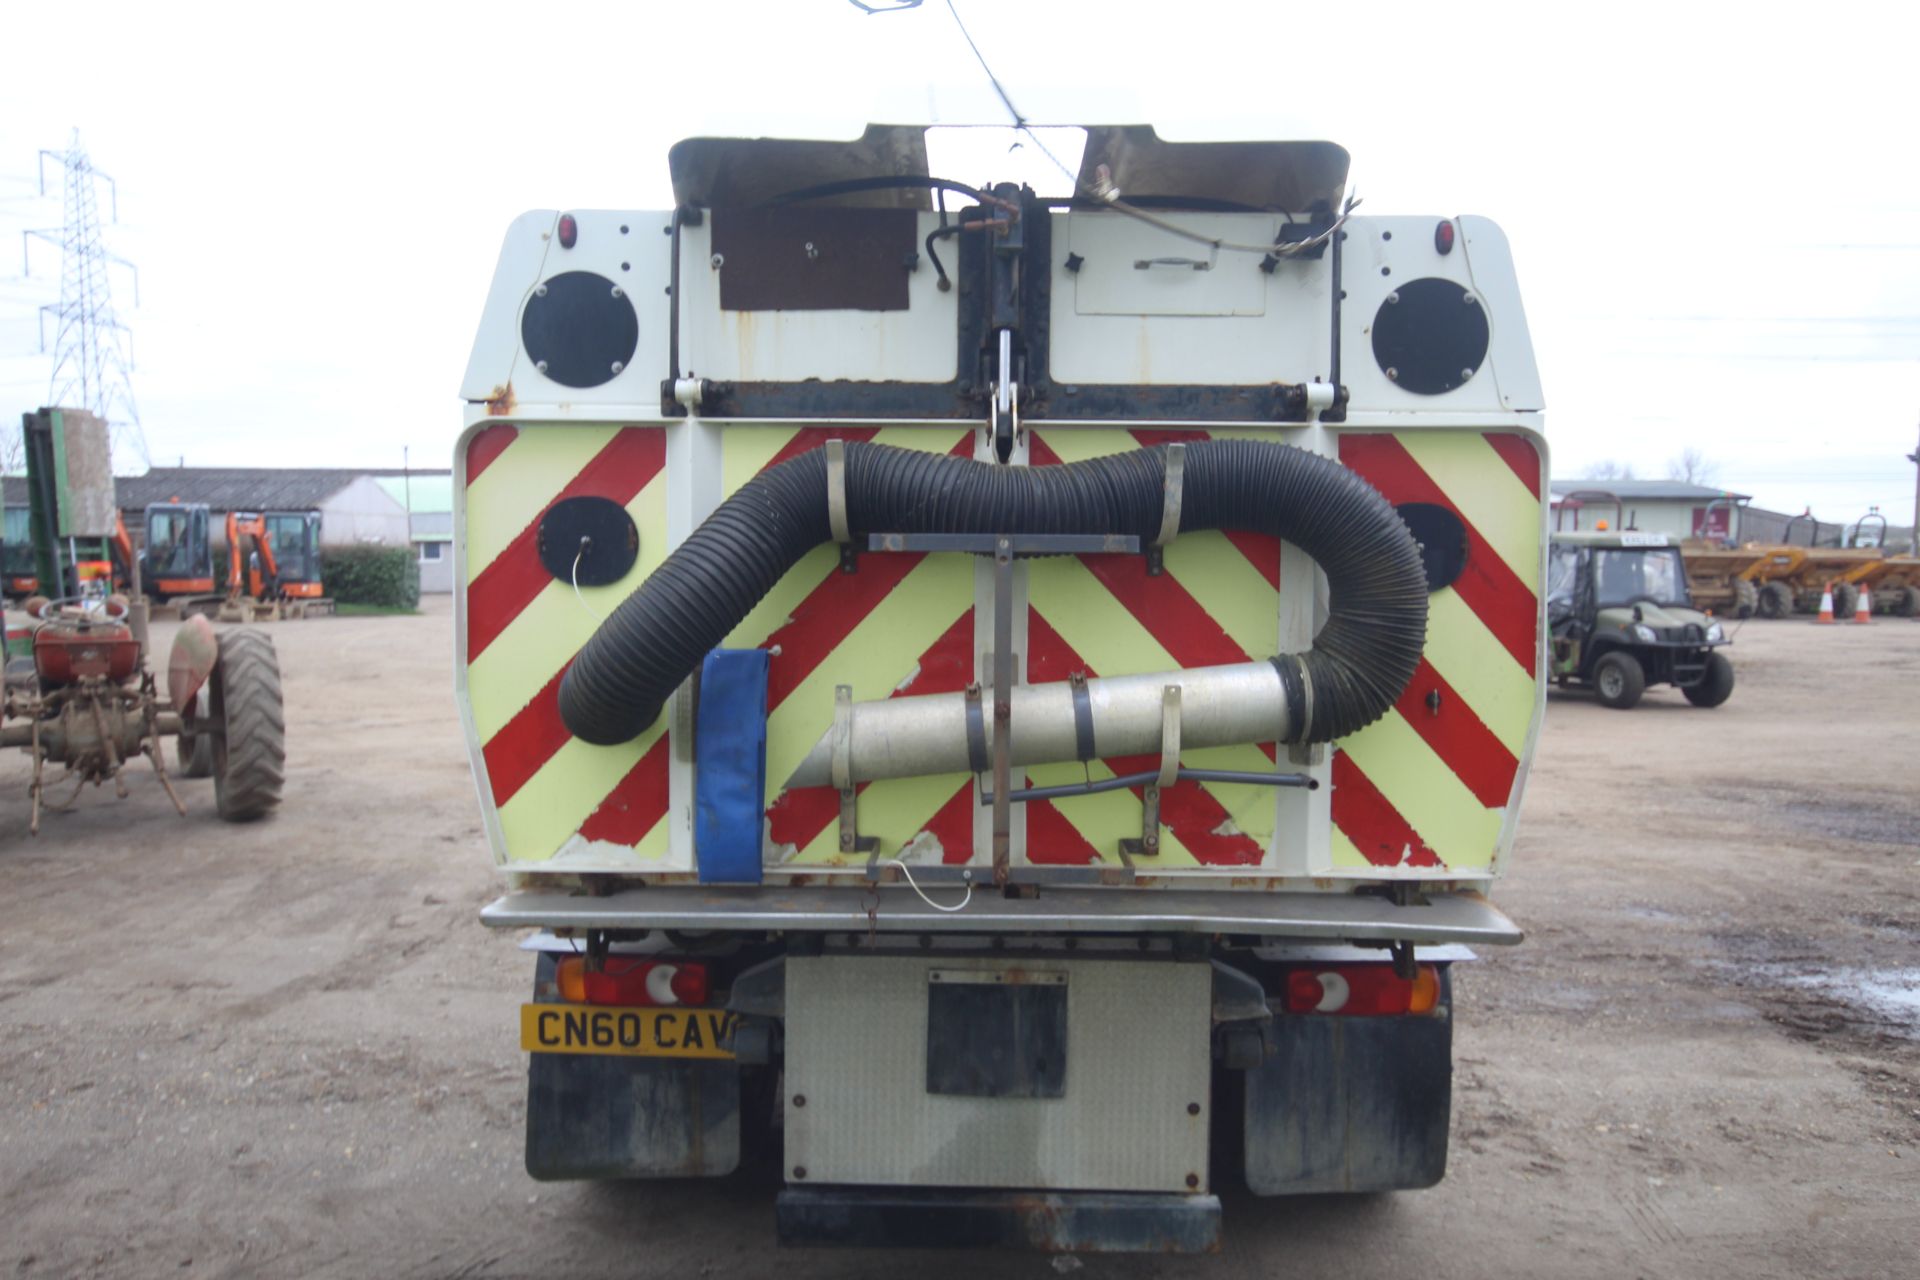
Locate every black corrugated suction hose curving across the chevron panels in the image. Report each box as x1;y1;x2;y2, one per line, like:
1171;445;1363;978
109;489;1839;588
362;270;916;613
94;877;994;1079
561;439;1427;745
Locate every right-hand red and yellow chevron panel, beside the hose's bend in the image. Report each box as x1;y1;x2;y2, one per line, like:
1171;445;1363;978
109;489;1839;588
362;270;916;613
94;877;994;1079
1332;430;1542;875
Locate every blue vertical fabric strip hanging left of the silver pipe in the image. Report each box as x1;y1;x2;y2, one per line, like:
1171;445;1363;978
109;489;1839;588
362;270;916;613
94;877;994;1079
693;649;768;885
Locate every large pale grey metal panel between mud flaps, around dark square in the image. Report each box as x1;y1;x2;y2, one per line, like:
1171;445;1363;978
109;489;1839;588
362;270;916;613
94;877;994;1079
783;952;1212;1194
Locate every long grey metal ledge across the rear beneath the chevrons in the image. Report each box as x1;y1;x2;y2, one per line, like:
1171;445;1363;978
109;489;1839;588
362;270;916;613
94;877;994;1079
480;887;1521;946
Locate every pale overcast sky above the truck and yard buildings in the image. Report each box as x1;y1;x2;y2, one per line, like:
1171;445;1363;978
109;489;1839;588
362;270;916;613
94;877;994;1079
0;0;1920;522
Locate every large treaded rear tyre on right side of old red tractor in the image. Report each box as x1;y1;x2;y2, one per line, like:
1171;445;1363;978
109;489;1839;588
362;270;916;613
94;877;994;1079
213;628;286;821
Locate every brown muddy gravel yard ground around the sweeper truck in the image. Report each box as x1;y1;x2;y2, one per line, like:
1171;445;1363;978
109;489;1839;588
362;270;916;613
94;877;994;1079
0;601;1920;1280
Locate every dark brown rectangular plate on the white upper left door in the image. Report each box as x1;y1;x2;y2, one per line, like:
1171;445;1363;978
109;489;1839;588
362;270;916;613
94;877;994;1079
712;207;920;311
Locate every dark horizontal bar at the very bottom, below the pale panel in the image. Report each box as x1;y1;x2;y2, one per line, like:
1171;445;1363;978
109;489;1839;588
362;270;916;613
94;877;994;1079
774;1186;1219;1253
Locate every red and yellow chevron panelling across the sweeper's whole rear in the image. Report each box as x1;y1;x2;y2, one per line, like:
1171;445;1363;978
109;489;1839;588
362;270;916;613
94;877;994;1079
461;424;1542;875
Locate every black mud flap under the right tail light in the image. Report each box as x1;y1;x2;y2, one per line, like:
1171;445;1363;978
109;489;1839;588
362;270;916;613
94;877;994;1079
1246;984;1453;1196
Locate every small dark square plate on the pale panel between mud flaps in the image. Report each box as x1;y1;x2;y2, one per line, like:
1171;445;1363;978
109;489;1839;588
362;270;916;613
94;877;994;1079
927;969;1068;1098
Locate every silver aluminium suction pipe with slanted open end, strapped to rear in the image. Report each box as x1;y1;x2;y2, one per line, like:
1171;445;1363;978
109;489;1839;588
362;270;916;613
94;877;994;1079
787;658;1292;787
